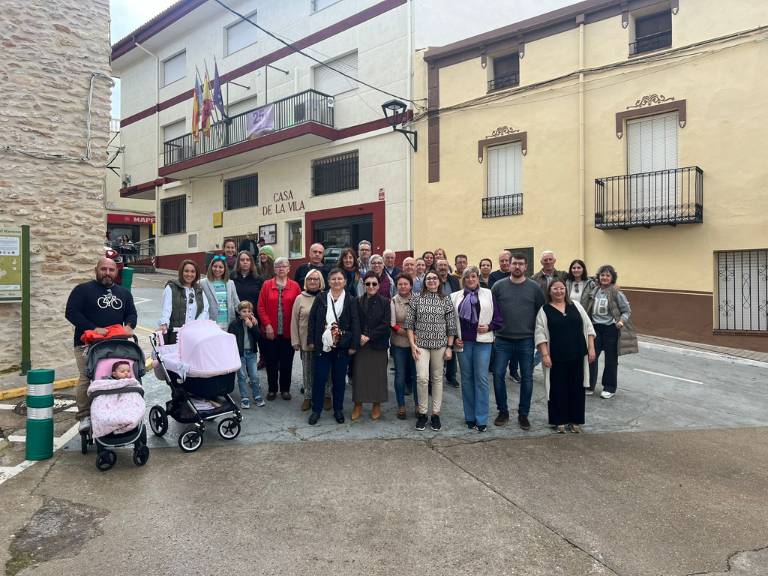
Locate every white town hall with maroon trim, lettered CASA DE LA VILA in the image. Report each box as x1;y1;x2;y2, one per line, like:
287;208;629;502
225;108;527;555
112;0;412;268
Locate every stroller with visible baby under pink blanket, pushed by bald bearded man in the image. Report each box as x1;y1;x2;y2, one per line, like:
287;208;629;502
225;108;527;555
80;336;149;471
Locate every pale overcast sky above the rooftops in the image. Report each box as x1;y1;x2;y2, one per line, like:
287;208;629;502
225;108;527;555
110;0;577;118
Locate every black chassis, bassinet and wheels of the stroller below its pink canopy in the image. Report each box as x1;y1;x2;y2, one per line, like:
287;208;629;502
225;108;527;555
149;328;243;452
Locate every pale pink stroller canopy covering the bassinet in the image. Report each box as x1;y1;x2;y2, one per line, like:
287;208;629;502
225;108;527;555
178;320;240;378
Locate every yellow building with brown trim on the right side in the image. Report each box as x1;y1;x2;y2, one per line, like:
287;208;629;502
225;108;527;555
414;0;768;350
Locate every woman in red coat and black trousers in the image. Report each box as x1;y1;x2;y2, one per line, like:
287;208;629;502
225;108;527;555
256;258;301;400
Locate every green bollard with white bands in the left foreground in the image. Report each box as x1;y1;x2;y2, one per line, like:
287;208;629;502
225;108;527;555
27;368;55;460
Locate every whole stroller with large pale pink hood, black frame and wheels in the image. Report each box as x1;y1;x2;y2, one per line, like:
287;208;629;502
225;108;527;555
149;320;243;452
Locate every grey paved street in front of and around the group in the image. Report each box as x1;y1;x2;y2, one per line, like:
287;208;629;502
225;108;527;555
0;277;768;576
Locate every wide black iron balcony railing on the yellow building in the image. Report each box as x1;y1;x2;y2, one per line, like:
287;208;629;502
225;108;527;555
595;166;704;230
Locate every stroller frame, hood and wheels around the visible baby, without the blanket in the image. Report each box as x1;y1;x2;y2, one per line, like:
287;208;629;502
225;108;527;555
80;336;149;471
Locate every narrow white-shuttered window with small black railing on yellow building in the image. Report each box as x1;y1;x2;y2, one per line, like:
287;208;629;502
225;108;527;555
483;142;523;218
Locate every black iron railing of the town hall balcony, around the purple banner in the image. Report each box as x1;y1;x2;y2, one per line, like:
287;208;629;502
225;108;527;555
163;90;333;166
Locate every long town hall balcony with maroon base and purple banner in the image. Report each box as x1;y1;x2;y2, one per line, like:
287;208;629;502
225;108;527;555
159;90;335;178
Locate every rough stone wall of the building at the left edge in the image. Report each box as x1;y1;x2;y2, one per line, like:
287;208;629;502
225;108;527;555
0;0;111;374
